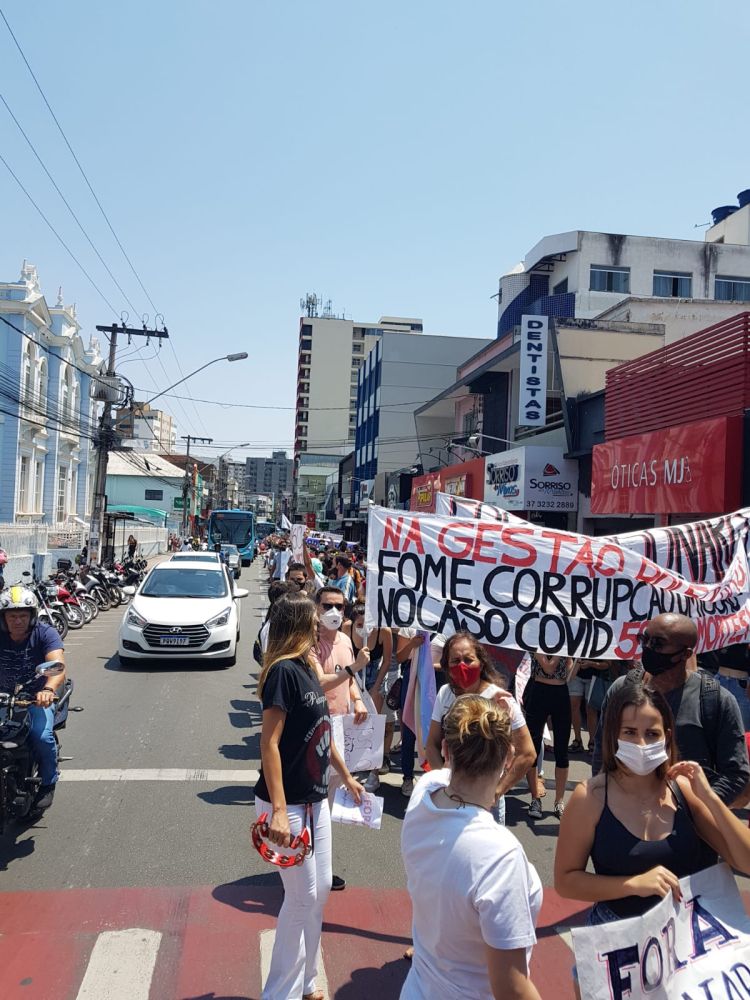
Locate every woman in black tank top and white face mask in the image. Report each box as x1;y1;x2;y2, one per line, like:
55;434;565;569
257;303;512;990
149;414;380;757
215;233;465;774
555;681;750;924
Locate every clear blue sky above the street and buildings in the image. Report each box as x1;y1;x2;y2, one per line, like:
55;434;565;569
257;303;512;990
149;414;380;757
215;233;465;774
0;0;750;458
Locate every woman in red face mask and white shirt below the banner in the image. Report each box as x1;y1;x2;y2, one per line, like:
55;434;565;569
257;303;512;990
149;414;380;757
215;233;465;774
425;632;536;825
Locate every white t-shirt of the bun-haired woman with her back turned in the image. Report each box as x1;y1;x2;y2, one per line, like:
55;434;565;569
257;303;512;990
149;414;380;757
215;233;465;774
401;768;542;1000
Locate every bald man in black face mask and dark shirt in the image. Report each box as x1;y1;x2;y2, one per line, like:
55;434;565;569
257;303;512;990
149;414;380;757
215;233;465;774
592;614;750;806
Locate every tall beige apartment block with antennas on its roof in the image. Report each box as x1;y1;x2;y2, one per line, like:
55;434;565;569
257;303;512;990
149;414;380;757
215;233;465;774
294;316;422;464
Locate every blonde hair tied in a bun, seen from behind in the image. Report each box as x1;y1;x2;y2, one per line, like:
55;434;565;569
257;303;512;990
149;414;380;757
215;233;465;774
443;694;511;775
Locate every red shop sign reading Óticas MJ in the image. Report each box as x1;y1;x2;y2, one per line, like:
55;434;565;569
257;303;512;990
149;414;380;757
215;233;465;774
591;417;742;514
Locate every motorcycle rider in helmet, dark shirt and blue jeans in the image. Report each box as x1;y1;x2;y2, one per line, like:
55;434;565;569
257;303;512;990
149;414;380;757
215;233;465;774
0;585;65;809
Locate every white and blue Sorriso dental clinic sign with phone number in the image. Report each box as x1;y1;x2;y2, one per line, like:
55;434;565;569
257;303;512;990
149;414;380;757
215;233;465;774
484;445;578;510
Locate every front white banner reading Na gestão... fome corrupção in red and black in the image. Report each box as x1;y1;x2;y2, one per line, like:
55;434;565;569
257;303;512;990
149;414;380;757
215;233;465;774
365;506;750;660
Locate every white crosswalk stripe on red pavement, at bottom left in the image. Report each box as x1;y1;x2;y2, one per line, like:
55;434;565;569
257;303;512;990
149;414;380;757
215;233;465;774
76;927;161;1000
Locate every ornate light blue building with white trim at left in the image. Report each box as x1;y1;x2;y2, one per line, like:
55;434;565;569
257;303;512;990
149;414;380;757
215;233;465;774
0;261;104;524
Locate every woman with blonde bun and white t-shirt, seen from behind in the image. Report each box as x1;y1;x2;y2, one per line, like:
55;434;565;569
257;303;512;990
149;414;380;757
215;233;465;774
401;695;542;1000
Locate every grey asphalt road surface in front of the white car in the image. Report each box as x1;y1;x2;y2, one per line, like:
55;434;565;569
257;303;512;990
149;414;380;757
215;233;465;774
0;565;600;891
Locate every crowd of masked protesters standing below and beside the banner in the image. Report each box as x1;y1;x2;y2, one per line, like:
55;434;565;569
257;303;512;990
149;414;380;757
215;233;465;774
255;536;750;1000
